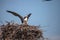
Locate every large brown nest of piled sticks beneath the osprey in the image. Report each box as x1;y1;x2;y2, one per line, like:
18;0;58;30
0;23;43;40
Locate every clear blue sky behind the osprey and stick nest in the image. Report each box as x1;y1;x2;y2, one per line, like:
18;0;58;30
0;0;60;40
